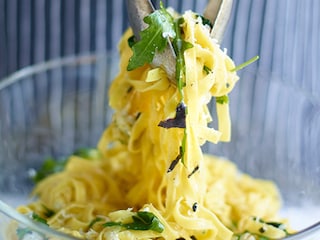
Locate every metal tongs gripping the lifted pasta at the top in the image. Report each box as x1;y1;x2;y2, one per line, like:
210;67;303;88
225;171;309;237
126;0;233;82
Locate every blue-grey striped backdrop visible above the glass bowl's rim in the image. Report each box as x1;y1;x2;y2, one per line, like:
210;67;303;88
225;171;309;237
0;0;320;93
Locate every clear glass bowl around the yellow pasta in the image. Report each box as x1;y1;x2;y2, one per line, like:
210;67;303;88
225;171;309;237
0;53;320;240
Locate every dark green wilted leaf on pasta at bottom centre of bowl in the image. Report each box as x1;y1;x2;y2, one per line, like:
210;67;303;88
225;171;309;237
103;211;164;233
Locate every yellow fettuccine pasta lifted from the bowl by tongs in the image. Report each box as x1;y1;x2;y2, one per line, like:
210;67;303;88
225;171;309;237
15;11;285;240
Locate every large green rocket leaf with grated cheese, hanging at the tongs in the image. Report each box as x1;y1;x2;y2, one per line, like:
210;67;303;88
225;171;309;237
127;4;175;71
